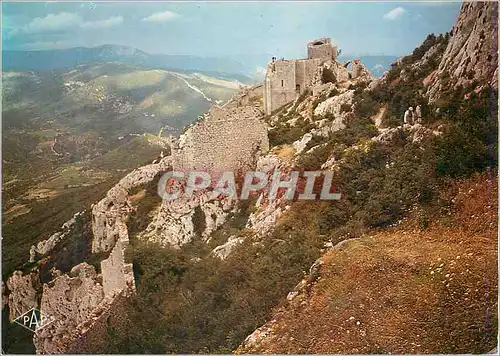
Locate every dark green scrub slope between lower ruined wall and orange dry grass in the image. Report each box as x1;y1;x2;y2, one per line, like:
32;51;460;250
105;200;328;353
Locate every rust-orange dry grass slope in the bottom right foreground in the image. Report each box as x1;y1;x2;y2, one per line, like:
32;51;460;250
239;176;498;353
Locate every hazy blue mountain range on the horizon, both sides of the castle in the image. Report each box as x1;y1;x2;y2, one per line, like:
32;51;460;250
2;44;397;80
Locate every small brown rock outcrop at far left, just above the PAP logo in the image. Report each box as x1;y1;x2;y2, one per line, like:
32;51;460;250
7;270;40;321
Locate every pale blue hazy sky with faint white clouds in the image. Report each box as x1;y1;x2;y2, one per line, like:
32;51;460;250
2;2;460;58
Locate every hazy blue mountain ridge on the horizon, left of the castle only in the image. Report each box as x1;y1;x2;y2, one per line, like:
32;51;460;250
2;45;252;83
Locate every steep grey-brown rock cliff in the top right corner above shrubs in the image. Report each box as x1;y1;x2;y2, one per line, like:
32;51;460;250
427;2;498;102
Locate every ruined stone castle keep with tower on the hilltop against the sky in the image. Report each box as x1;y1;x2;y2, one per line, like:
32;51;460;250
264;38;337;115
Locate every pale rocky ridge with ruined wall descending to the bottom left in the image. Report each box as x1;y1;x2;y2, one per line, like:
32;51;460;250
31;157;171;353
